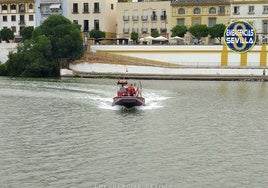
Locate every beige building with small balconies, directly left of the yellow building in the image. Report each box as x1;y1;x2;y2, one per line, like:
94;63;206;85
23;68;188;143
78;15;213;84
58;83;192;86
116;1;171;42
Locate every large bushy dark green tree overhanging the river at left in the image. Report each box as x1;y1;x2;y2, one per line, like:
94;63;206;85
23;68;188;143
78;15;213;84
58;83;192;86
6;15;83;77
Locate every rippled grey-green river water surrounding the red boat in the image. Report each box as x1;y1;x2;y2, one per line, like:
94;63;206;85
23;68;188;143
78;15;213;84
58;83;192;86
0;77;268;188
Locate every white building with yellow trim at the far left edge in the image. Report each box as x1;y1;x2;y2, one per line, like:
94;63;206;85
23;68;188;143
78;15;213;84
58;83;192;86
0;0;36;40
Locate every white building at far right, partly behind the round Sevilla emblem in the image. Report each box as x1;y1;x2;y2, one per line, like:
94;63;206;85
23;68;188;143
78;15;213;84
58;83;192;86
230;0;268;44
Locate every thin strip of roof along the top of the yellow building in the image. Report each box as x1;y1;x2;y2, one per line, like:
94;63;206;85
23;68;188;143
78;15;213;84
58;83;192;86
171;0;230;6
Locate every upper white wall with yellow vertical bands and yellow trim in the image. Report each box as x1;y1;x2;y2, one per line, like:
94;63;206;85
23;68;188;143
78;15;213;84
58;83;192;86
90;45;268;67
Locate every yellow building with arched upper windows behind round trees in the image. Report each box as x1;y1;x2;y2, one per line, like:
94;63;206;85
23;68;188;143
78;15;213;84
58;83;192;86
171;0;230;44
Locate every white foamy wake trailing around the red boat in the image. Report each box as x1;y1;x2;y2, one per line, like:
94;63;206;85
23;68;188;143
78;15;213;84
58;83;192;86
13;82;170;111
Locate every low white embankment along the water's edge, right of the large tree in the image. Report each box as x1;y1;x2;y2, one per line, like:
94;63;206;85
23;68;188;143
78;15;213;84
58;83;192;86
61;62;268;81
